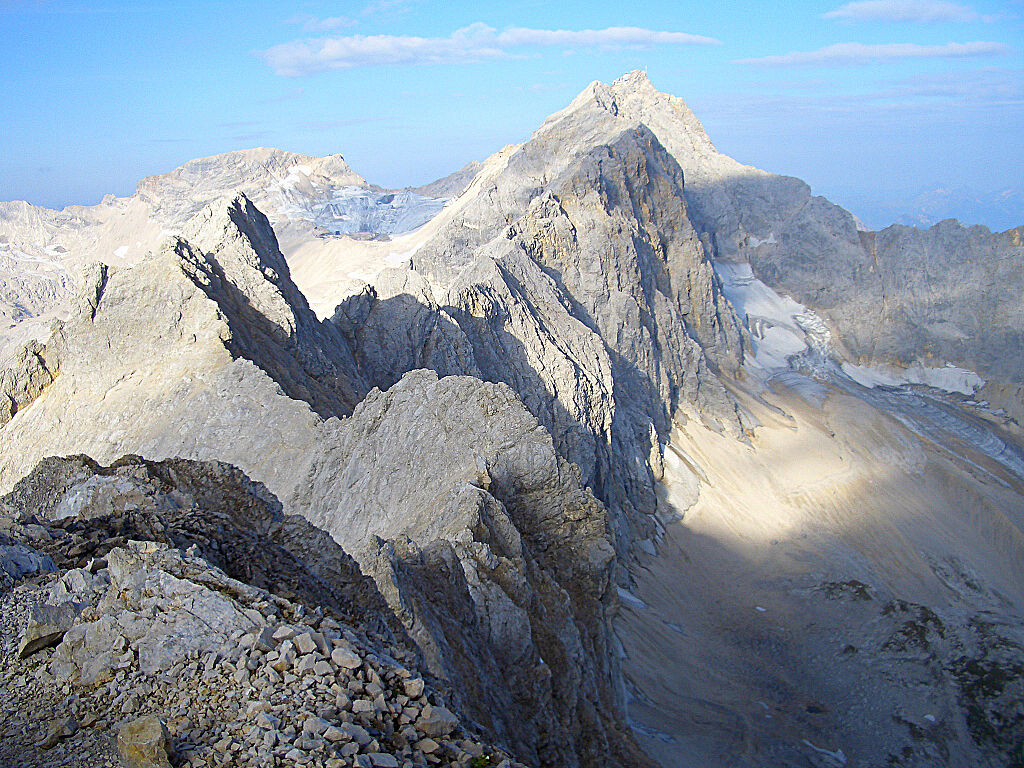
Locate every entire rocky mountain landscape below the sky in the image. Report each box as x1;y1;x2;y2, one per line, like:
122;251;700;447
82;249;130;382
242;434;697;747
0;72;1024;768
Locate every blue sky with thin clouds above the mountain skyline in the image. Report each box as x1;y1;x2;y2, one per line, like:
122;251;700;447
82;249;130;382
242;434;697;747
0;0;1024;225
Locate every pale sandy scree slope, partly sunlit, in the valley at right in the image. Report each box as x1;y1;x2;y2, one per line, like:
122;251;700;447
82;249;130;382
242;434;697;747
616;375;1024;767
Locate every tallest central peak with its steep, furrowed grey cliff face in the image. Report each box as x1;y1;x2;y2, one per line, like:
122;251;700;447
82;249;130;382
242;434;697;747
333;104;743;543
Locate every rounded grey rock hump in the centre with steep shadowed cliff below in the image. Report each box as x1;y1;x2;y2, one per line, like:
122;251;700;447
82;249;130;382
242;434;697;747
296;371;642;765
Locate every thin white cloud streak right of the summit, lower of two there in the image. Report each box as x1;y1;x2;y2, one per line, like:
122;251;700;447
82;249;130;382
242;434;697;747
735;41;1008;67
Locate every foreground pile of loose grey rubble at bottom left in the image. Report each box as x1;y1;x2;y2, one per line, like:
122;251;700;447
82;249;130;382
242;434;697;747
0;461;518;768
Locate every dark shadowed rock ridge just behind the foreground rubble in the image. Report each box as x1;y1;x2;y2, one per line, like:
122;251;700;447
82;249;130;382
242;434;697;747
0;456;391;629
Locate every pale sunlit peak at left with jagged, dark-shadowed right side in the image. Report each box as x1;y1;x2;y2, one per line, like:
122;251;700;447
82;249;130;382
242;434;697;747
0;192;361;507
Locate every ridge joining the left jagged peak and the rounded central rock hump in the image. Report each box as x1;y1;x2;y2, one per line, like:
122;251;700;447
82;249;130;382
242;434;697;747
0;191;644;765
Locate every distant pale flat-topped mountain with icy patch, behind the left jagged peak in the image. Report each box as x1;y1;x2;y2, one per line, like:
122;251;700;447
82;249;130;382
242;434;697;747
0;147;445;365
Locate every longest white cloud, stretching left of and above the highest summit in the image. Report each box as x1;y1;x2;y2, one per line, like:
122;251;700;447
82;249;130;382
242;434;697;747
260;24;719;77
